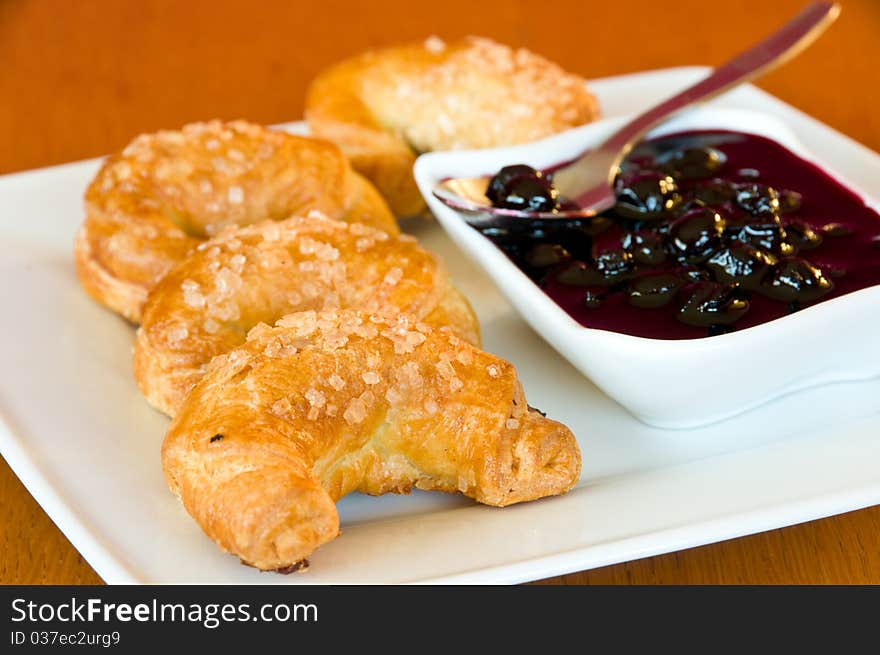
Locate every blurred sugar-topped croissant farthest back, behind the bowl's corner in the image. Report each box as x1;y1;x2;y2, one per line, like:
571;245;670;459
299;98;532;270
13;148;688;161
306;37;599;216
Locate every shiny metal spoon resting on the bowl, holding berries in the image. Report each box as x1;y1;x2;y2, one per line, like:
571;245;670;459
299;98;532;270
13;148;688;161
433;2;840;223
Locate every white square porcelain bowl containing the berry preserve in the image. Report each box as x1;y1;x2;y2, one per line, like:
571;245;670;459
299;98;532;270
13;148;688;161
415;104;880;428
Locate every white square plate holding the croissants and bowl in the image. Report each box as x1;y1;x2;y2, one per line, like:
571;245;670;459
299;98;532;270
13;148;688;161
0;68;880;584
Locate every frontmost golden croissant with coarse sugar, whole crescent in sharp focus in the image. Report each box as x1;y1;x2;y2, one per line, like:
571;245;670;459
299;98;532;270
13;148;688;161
162;310;580;570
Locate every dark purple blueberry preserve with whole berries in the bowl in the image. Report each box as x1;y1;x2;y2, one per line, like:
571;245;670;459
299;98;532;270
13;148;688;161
479;131;880;339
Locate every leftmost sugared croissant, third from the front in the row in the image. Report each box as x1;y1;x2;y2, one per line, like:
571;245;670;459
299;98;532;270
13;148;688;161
75;121;397;322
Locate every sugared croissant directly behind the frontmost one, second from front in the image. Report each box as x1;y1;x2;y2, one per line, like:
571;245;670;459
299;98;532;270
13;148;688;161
134;215;479;416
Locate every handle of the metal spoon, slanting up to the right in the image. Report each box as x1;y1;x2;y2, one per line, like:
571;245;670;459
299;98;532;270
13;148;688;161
567;2;840;206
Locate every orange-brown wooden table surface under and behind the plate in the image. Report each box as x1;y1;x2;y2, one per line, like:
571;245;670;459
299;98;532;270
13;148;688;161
0;0;880;584
